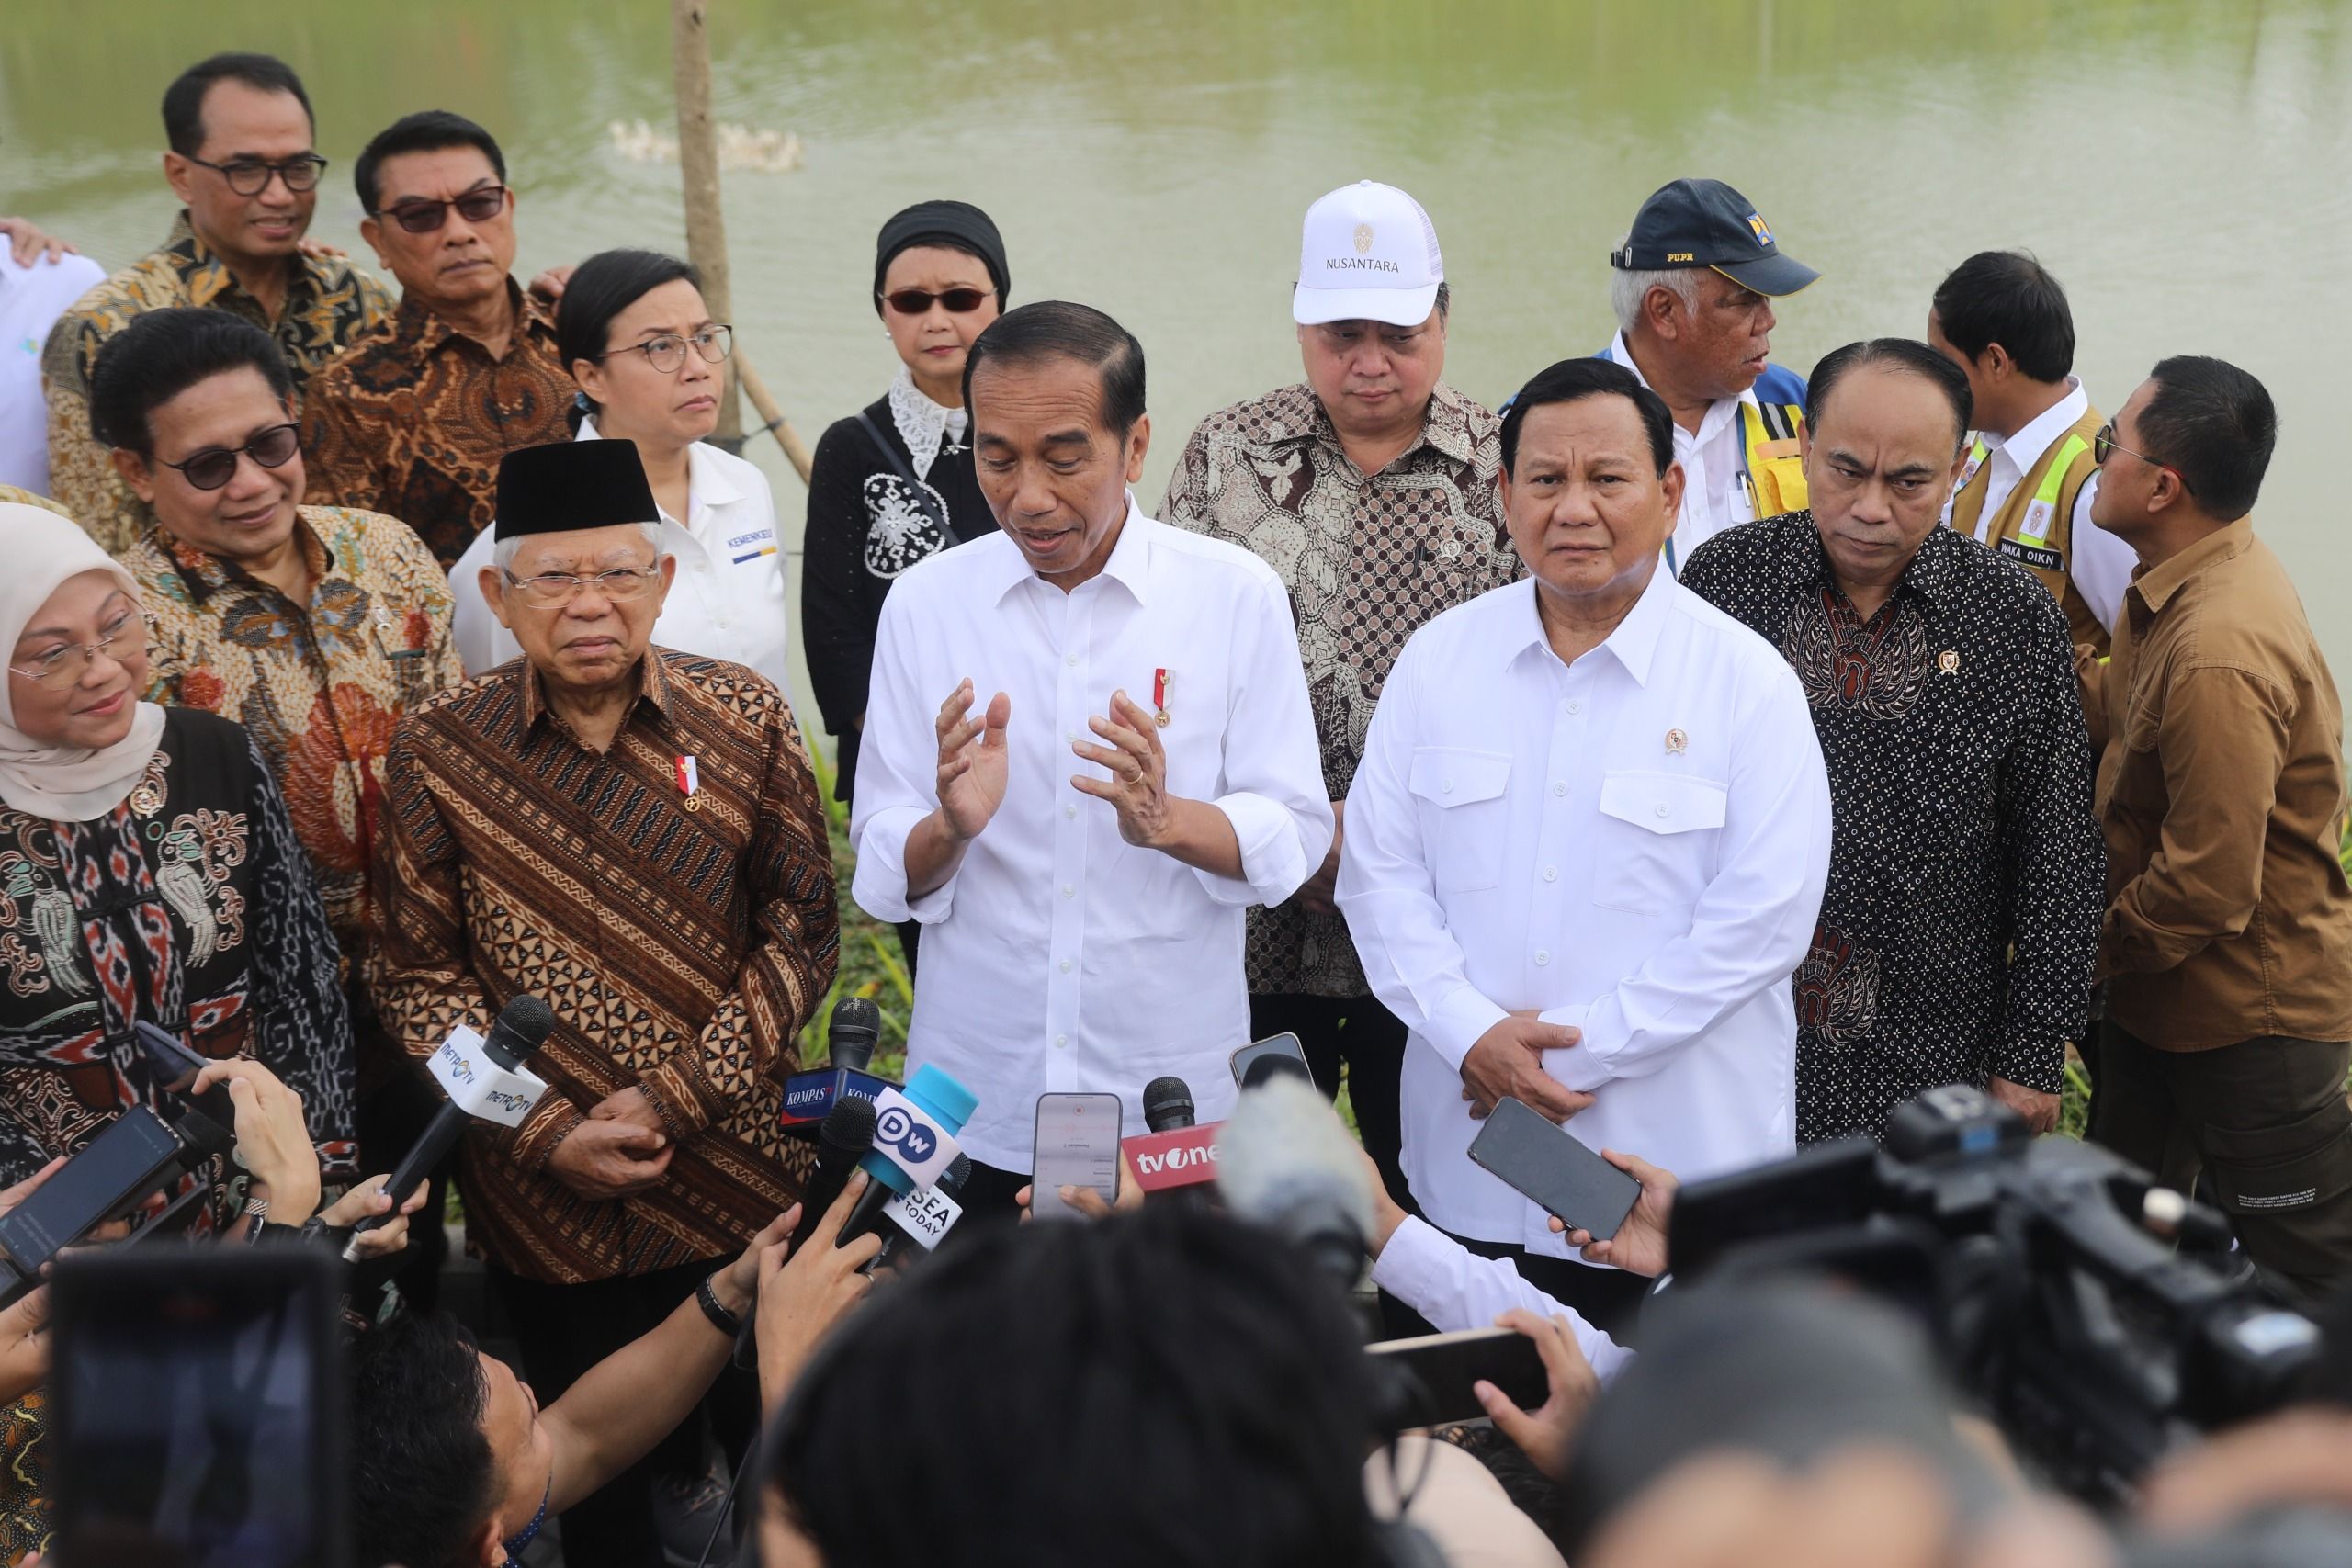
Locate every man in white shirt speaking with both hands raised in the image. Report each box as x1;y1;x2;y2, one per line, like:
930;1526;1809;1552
852;301;1331;1213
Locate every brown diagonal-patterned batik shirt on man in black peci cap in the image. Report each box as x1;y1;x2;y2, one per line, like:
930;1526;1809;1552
377;649;840;1283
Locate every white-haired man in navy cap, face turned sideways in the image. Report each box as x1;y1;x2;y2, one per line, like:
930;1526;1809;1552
1601;179;1820;573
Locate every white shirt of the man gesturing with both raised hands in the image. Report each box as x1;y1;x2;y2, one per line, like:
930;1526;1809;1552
852;496;1331;1170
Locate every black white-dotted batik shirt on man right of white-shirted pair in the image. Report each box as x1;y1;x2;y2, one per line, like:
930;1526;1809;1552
1681;513;2108;1143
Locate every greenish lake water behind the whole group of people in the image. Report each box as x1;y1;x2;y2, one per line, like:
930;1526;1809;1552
0;0;2352;677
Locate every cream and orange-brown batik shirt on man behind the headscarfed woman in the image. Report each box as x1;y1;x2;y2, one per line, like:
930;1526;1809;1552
122;505;466;964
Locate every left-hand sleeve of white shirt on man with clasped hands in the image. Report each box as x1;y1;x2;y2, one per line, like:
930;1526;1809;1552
1339;639;1505;1072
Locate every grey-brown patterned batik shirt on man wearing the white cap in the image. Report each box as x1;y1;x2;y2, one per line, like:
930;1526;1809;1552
1162;383;1521;997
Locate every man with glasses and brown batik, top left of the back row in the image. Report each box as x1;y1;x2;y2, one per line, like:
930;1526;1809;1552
40;54;393;552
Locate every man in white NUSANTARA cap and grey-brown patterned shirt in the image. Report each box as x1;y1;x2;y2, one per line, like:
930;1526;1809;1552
1162;179;1520;1194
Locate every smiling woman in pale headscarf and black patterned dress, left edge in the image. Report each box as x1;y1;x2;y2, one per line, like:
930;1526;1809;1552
0;505;356;1229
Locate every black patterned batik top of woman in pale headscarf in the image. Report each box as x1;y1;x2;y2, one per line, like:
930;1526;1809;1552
0;710;356;1224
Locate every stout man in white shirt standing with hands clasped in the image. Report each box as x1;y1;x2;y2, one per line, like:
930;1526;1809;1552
1339;360;1830;1333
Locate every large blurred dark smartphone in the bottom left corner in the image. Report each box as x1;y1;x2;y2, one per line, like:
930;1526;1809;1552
50;1246;350;1568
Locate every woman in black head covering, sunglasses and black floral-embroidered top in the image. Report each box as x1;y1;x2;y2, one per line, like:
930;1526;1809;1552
799;202;1012;799
